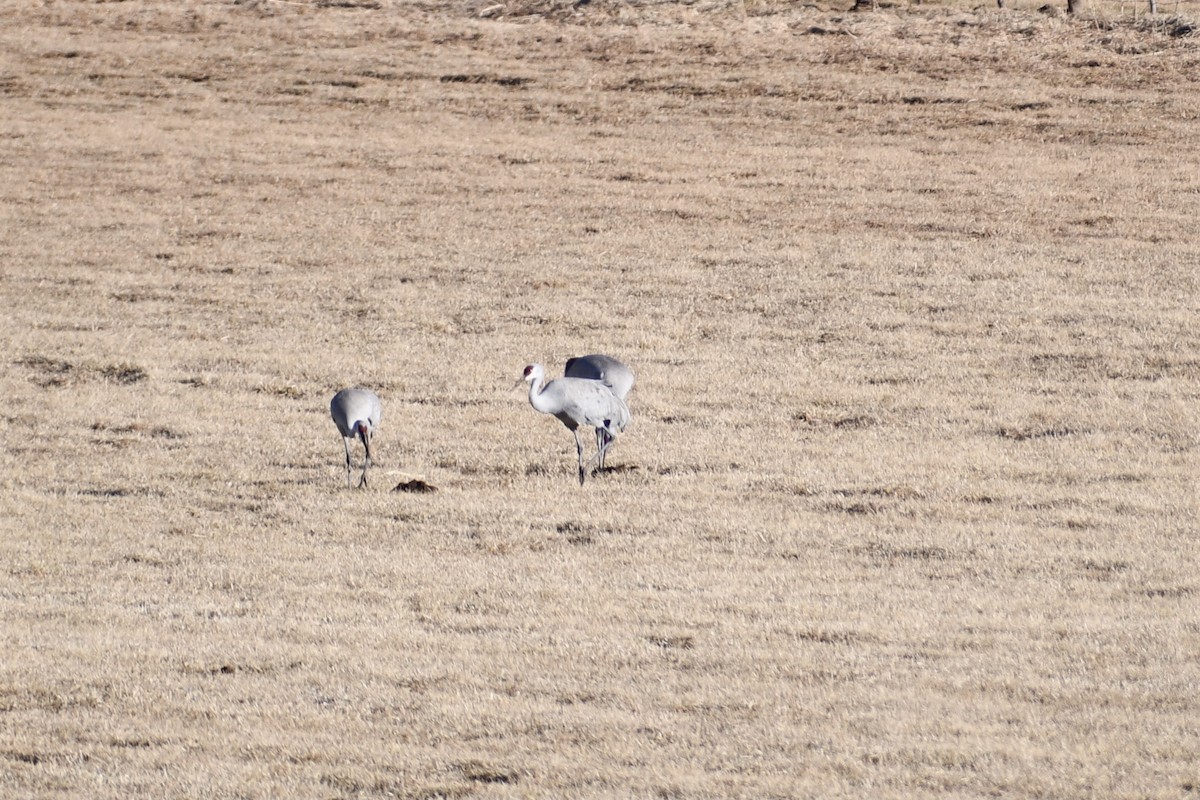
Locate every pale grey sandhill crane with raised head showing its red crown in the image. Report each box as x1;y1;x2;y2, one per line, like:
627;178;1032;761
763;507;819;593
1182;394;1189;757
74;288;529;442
524;363;629;486
